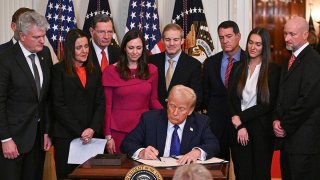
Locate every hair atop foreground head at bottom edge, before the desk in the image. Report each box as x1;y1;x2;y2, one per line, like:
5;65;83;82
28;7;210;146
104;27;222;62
172;163;213;180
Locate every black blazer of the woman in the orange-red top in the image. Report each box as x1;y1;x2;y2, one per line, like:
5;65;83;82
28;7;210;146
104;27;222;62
52;61;105;138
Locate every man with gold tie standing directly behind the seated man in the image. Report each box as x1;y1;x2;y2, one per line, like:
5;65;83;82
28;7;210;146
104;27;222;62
149;24;202;110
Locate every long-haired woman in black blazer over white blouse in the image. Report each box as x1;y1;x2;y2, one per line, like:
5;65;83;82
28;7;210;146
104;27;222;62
229;27;280;180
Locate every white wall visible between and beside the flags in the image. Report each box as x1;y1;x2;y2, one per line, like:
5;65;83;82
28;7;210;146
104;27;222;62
0;0;252;52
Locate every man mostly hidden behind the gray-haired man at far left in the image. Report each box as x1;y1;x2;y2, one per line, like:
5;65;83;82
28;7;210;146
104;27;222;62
0;7;34;53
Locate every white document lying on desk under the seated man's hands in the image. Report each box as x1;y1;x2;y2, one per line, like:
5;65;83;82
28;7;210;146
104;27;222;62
136;157;227;167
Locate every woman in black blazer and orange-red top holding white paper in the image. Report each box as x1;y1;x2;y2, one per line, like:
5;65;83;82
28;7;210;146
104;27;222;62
52;29;105;179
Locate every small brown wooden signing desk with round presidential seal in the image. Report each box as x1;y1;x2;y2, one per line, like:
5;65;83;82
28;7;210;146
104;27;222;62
69;158;229;180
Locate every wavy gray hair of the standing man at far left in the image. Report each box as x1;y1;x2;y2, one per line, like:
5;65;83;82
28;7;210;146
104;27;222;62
14;12;49;40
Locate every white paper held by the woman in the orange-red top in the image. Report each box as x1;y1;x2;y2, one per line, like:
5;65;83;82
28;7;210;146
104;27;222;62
68;138;107;164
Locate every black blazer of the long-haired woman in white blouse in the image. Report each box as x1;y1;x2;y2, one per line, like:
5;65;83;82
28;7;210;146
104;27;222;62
228;62;280;134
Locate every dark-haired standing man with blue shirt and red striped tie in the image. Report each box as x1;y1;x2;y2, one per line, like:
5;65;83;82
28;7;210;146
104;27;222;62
203;21;245;160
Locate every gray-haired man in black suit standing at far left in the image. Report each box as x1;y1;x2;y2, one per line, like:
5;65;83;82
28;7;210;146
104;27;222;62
0;12;52;180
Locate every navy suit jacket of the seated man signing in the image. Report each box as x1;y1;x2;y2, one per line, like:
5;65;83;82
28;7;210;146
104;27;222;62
121;109;219;158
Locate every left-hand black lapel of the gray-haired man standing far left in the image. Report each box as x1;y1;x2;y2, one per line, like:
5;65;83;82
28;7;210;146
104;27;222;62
14;43;38;99
